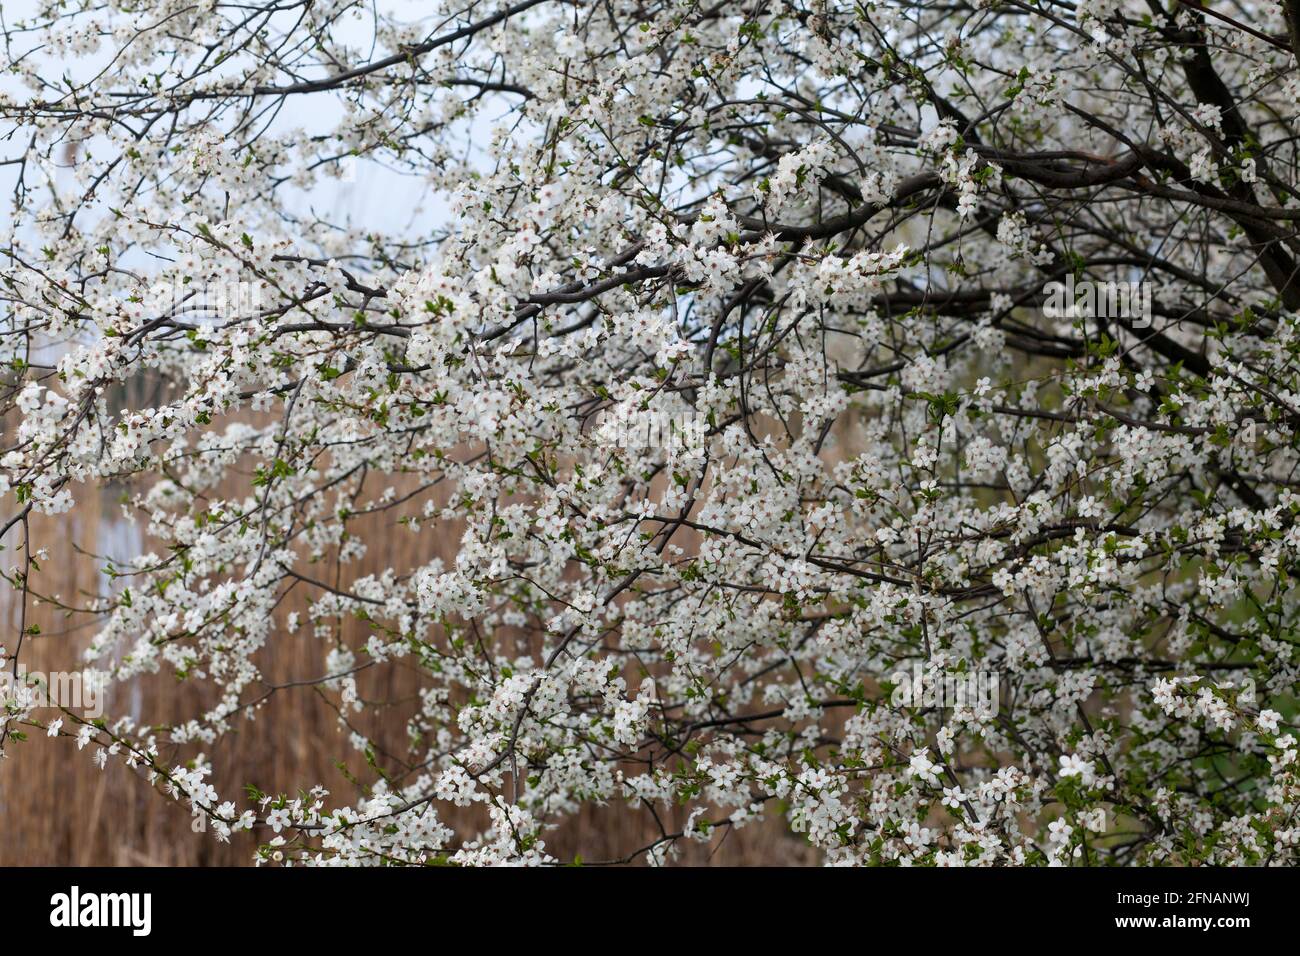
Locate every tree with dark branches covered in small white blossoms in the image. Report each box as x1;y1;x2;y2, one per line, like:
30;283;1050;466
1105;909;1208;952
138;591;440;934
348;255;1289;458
0;0;1300;865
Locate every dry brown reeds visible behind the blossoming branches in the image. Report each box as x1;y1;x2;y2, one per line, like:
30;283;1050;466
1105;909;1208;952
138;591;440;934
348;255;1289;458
0;418;832;866
